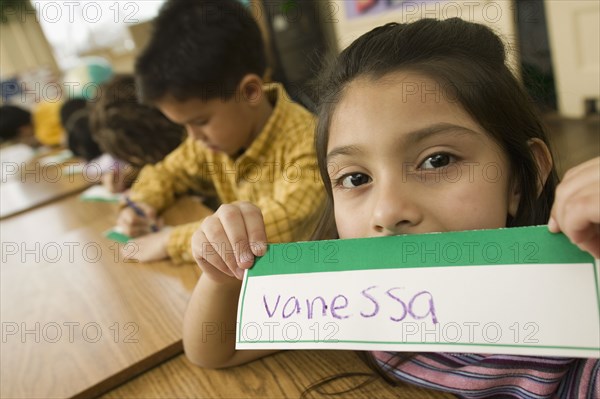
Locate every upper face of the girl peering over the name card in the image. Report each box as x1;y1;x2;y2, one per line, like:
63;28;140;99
327;72;519;238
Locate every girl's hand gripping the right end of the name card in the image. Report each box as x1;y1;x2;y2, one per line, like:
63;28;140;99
548;157;600;258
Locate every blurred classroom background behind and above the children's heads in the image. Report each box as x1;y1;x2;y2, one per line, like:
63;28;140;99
0;0;600;172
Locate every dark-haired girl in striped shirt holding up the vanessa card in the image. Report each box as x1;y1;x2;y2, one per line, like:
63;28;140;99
184;19;600;398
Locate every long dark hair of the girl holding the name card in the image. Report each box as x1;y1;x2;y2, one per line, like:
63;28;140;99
315;18;558;238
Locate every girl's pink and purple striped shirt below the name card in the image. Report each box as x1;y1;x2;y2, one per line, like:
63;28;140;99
373;352;599;399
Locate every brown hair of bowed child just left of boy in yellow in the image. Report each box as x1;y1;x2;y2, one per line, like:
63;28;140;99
90;75;185;168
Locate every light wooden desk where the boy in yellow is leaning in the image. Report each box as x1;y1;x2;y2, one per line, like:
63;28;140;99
0;197;210;398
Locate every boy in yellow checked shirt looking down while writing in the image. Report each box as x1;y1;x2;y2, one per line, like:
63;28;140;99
118;0;324;262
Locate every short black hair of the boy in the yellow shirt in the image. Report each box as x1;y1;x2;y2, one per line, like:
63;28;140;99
135;0;267;104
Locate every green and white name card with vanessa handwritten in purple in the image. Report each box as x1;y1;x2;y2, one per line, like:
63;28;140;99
236;226;600;357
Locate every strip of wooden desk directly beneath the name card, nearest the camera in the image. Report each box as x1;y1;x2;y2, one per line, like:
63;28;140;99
102;351;455;399
